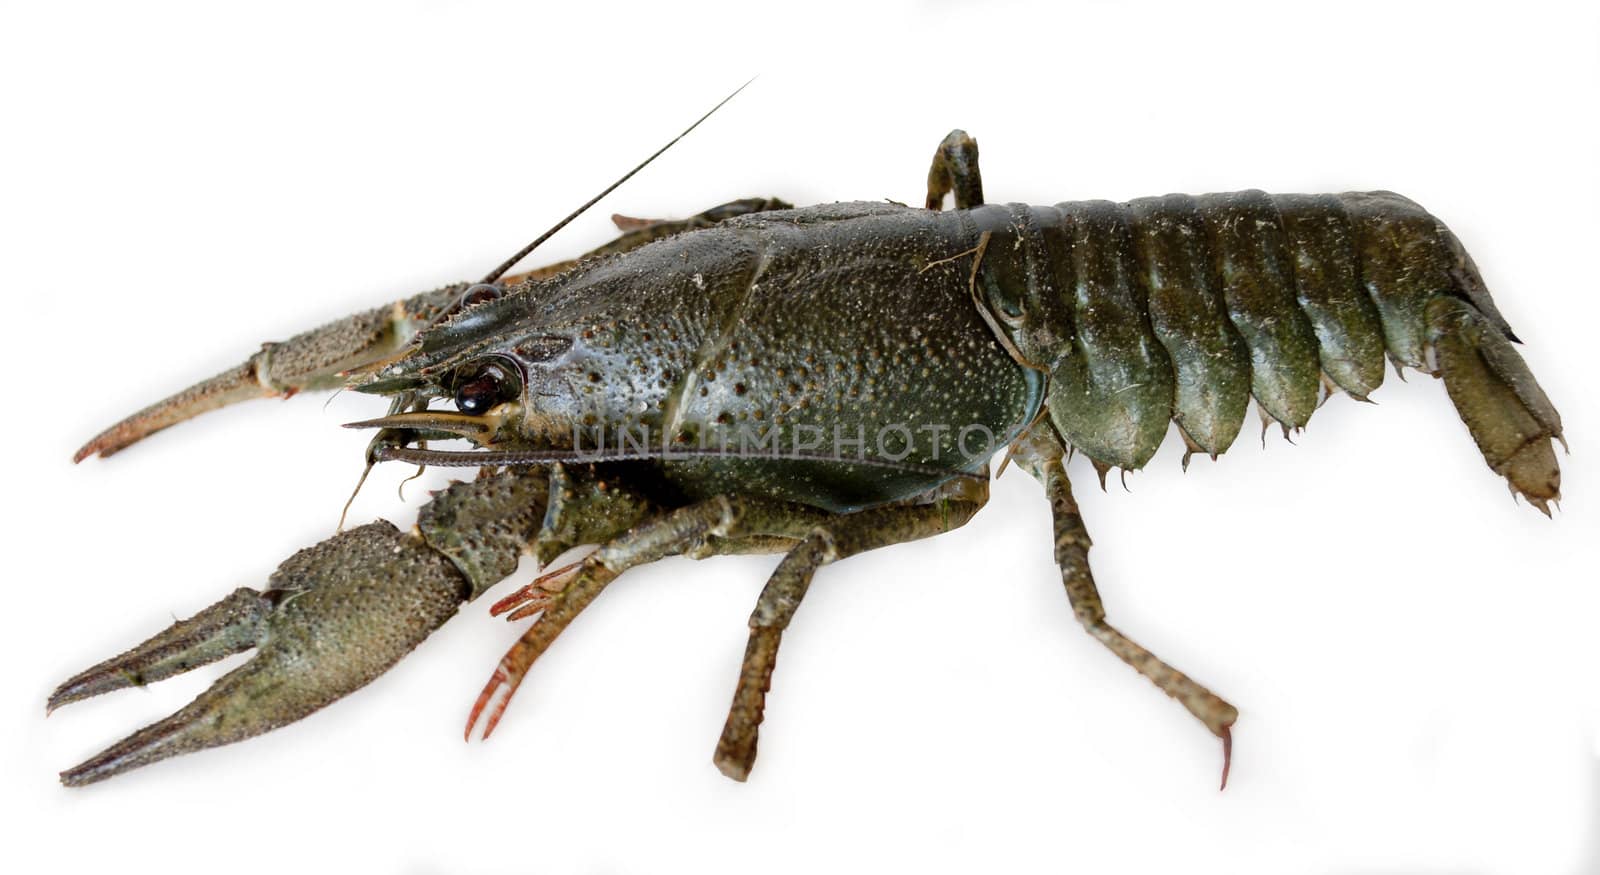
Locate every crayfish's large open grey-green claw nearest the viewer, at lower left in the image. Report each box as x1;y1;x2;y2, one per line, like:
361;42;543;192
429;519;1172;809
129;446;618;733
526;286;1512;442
48;521;467;787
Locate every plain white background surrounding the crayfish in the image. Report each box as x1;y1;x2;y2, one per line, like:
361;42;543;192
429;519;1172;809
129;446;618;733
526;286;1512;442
0;0;1600;873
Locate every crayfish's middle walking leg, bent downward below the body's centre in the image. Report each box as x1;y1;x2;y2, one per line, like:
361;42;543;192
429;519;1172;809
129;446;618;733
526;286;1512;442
714;480;989;781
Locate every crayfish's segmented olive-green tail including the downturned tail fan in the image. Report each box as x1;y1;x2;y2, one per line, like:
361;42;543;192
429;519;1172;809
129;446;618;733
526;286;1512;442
968;190;1562;513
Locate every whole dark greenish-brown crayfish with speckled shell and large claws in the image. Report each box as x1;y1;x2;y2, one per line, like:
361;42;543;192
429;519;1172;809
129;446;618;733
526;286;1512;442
50;101;1562;785
